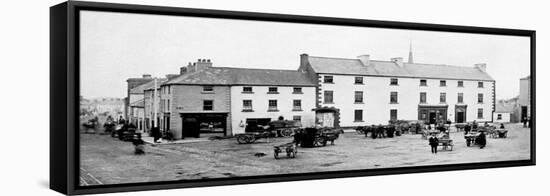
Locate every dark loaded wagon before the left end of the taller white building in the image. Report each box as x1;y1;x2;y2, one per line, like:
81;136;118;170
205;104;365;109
294;127;344;147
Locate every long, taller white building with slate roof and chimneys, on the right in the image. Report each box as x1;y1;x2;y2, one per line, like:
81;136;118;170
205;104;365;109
298;54;495;127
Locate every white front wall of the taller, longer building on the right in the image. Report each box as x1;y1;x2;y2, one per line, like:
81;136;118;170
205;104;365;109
319;74;493;126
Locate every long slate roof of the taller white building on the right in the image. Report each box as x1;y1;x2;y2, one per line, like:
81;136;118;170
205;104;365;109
308;56;494;81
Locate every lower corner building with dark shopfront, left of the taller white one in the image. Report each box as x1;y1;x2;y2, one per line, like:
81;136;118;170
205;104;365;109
160;59;315;139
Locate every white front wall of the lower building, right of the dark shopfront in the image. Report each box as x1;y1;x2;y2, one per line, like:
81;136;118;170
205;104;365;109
230;86;315;134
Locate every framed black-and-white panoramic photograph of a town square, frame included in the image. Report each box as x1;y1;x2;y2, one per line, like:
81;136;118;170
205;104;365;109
50;1;536;194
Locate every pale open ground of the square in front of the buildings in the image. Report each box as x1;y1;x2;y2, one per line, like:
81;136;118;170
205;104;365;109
81;124;530;185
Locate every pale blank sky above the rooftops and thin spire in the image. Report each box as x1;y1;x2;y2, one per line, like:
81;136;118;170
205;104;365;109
80;11;530;99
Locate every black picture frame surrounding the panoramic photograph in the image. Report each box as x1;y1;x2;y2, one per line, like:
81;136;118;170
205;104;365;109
50;1;536;195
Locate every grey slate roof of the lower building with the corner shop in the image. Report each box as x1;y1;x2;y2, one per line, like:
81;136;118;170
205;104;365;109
166;67;316;86
